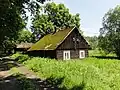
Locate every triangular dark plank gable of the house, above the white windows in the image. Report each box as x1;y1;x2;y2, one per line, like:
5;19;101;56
57;27;89;50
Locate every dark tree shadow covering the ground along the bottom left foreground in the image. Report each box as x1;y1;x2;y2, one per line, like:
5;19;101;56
0;75;65;90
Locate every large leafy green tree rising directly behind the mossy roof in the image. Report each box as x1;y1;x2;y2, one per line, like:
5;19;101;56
32;3;80;39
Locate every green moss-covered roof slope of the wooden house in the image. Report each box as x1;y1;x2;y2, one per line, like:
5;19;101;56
28;27;74;51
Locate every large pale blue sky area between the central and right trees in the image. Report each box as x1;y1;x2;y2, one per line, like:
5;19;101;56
53;0;120;36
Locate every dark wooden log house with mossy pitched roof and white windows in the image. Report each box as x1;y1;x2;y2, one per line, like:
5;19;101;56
28;27;90;60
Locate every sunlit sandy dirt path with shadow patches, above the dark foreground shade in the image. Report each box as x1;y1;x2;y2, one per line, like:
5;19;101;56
0;60;38;78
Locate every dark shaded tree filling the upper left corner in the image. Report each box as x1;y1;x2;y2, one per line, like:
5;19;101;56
0;0;45;52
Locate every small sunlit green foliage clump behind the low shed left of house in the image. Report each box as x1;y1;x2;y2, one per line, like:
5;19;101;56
17;30;32;43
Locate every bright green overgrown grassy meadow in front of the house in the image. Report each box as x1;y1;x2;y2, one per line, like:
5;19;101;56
11;51;120;90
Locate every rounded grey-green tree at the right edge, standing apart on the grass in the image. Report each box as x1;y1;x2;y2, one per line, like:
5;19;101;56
99;6;120;58
